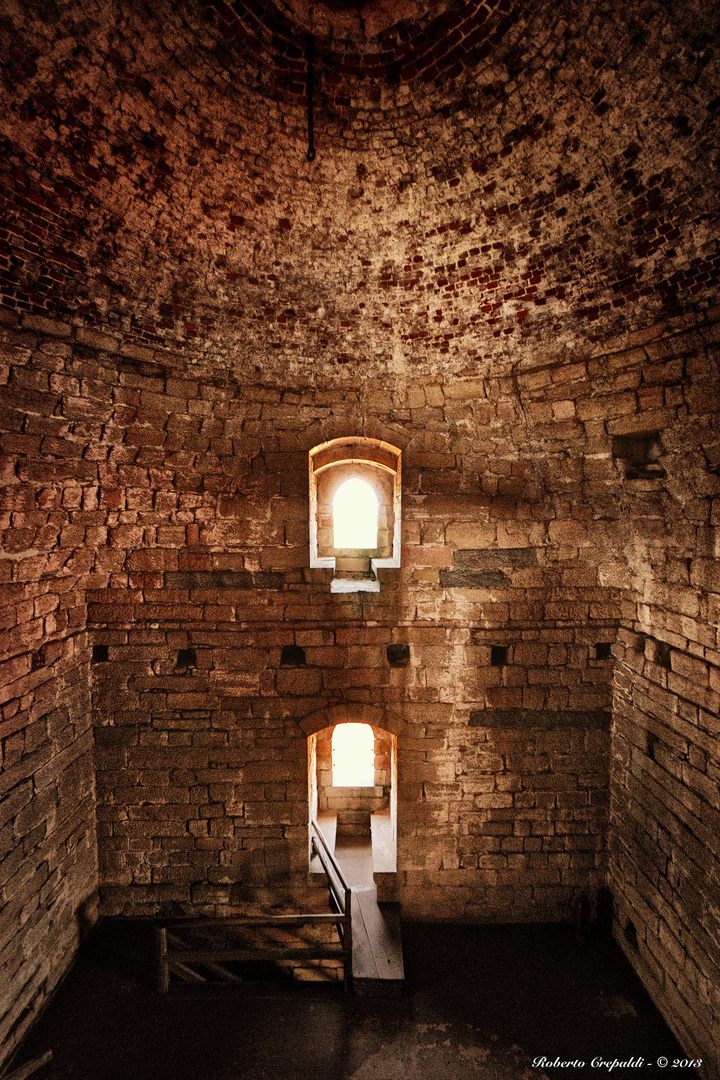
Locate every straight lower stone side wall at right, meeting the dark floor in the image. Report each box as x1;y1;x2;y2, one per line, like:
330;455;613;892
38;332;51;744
610;633;720;1077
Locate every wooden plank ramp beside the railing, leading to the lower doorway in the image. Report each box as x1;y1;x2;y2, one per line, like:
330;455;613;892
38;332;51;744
352;886;405;996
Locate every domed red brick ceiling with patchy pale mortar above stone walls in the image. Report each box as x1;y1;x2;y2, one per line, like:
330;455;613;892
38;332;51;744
0;0;720;383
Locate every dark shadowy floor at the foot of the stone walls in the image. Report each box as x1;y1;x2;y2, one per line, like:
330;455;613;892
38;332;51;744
8;922;690;1080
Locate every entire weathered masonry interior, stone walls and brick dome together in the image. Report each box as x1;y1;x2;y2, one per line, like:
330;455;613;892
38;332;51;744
0;0;720;1080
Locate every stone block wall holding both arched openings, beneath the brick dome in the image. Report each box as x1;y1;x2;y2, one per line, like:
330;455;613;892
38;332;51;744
3;293;717;1062
